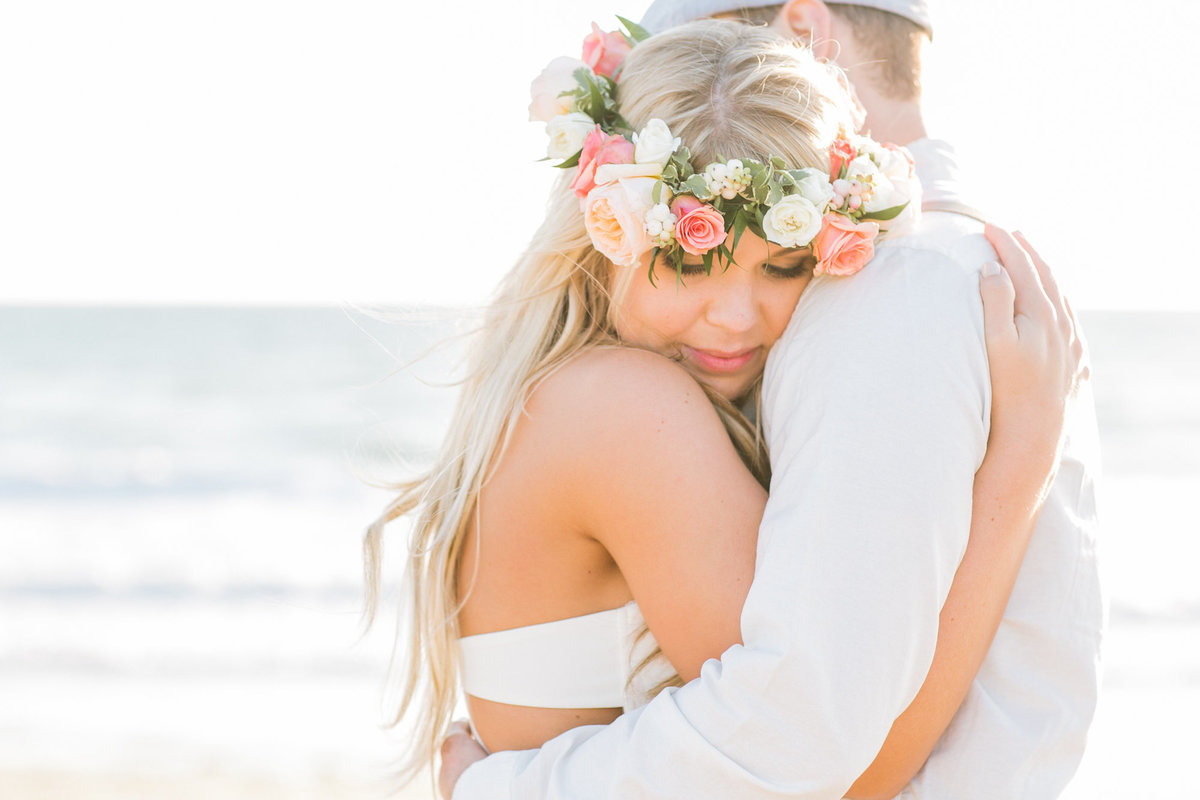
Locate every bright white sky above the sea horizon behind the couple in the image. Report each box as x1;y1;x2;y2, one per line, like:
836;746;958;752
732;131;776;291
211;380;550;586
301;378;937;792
0;0;1200;309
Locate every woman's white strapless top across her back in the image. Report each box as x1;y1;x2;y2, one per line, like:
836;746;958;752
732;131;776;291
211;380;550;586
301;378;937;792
458;602;674;710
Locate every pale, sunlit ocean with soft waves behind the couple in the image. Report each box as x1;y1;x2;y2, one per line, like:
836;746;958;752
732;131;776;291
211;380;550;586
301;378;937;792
0;307;1200;798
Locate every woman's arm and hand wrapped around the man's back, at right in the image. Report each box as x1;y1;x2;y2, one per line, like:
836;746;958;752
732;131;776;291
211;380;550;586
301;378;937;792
847;227;1086;800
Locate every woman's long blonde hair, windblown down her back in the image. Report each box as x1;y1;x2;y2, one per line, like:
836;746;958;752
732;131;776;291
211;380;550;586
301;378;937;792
364;20;850;781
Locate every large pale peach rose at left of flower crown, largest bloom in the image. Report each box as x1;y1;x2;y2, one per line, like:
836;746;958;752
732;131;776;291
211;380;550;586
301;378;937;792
583;178;658;266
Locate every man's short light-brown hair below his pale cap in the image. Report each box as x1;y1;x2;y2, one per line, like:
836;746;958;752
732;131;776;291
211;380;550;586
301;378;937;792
736;2;925;100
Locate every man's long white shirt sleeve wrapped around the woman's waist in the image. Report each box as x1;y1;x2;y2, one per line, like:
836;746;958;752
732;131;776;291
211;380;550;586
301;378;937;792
454;244;990;800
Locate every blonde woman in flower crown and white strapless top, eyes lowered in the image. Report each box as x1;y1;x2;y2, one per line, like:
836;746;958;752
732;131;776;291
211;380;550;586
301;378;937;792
366;22;1084;796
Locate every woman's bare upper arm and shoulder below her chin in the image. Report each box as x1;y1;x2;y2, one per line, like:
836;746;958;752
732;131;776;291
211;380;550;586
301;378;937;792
549;349;767;681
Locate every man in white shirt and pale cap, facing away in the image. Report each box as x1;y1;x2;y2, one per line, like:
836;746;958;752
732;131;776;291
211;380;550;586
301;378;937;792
445;0;1103;800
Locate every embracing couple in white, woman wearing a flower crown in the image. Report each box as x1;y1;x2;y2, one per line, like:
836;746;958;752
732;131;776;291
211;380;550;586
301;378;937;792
366;0;1103;800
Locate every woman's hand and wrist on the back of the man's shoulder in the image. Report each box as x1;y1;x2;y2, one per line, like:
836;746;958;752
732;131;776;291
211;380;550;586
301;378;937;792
979;225;1088;495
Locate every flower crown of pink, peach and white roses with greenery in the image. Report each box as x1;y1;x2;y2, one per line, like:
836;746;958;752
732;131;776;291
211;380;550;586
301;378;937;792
529;17;919;282
